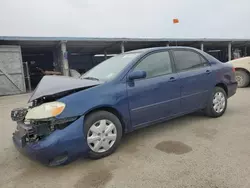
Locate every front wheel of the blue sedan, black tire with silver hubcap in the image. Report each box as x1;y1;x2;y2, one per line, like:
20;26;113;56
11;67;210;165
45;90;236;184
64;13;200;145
84;111;122;159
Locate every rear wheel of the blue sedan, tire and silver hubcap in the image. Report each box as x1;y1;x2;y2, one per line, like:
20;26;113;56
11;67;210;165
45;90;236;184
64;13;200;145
205;87;227;118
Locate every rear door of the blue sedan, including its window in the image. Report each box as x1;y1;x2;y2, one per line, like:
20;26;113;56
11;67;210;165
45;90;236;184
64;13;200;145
173;49;214;113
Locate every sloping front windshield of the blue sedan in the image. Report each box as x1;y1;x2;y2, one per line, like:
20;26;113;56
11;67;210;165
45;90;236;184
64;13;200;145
81;53;140;81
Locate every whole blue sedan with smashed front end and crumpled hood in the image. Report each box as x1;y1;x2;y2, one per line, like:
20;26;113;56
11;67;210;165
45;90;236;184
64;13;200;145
11;47;237;166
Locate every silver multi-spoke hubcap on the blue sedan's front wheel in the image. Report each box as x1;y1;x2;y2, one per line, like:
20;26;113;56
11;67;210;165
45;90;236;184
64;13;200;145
87;119;117;153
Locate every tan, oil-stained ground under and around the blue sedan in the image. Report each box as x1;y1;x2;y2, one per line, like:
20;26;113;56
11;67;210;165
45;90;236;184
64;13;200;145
0;88;250;188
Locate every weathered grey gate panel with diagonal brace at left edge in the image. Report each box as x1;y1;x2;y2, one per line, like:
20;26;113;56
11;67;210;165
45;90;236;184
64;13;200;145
0;46;26;95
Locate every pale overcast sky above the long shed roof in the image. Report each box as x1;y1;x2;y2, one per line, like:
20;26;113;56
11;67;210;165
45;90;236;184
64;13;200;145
0;0;250;39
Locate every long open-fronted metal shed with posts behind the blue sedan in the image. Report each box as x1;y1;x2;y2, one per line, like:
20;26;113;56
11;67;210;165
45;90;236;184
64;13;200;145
0;37;250;95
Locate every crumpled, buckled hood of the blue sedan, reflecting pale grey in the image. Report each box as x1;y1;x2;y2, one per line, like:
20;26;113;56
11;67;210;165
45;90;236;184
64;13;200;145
29;76;103;102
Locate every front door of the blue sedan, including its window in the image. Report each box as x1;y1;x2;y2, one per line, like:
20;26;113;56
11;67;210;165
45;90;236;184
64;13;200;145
127;51;180;127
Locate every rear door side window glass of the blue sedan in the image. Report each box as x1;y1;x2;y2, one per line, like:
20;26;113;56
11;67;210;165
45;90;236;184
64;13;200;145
174;50;208;71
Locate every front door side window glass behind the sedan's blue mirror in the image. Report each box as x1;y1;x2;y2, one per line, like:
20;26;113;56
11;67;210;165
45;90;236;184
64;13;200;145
134;52;172;78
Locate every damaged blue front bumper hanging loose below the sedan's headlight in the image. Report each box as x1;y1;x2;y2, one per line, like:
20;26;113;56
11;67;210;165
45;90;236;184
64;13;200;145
13;117;89;166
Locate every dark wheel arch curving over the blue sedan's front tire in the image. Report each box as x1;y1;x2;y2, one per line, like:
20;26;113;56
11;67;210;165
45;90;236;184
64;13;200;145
85;106;126;134
